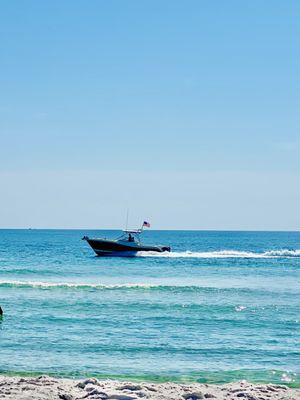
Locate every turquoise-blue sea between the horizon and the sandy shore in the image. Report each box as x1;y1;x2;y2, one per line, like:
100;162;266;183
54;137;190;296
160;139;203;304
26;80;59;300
0;230;300;386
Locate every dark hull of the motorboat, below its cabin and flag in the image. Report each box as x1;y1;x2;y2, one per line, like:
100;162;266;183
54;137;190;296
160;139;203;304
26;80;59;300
83;236;171;257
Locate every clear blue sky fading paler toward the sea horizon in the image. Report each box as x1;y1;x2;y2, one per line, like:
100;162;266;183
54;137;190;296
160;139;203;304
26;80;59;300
0;0;300;230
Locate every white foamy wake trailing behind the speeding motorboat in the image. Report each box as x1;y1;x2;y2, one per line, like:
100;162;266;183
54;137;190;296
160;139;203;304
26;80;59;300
137;249;300;258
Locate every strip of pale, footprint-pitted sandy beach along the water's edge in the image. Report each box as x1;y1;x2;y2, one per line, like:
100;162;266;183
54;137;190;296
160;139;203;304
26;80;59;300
0;376;300;400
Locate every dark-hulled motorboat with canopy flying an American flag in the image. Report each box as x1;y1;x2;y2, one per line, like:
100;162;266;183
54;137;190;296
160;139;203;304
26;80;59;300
82;222;171;257
